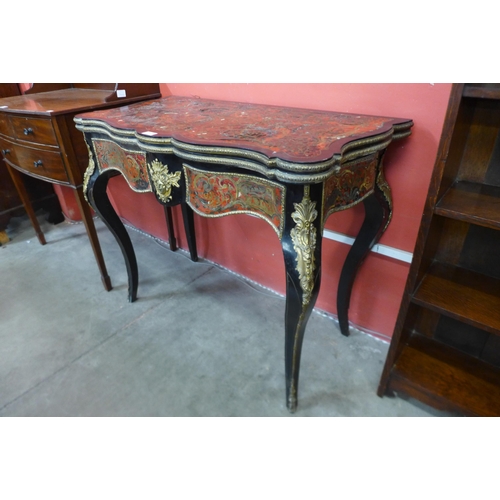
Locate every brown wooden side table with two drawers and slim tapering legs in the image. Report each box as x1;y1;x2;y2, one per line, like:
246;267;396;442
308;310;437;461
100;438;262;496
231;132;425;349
0;83;160;290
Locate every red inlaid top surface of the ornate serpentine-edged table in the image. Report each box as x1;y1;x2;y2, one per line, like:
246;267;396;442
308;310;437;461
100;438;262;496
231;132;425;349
78;96;410;163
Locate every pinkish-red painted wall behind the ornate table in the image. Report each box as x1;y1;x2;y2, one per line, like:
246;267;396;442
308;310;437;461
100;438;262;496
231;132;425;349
55;83;451;338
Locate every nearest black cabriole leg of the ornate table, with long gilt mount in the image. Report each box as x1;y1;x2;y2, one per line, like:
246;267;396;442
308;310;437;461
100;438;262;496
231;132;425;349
281;186;321;413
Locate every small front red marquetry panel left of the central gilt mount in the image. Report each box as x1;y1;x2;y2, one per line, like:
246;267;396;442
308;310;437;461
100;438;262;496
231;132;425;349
92;139;151;191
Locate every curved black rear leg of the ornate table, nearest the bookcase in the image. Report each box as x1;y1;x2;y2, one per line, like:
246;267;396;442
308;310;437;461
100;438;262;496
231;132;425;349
337;171;392;337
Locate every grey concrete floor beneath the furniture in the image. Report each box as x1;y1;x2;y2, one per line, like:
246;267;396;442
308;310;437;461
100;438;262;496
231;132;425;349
0;209;441;417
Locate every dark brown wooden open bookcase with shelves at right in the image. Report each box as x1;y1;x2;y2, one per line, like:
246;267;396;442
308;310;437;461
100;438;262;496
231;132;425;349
378;84;500;416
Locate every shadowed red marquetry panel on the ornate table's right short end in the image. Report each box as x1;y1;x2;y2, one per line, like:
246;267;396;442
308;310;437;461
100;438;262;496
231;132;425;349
323;155;378;221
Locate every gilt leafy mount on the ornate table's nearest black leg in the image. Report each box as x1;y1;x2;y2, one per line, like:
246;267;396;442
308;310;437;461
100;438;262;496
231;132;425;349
290;186;318;306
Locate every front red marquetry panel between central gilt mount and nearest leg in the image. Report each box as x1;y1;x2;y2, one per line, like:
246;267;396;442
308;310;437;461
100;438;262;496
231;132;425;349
184;165;285;238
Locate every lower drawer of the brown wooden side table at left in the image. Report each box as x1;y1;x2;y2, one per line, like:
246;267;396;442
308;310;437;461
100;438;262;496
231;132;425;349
11;144;69;182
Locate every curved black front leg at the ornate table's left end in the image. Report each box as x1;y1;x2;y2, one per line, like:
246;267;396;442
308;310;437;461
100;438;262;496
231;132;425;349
86;169;139;302
